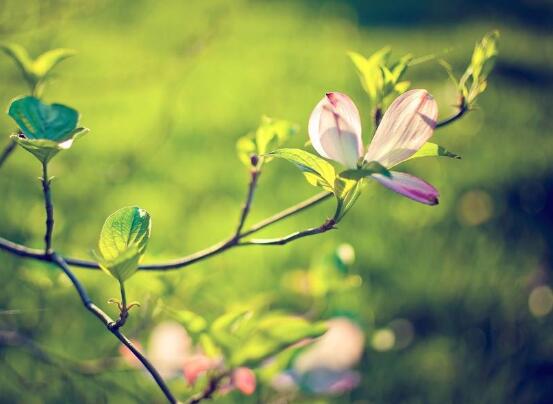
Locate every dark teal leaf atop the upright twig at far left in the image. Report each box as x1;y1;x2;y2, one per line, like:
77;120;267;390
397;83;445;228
8;96;79;142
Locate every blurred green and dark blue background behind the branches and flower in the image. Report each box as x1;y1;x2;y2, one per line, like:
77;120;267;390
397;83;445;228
0;0;553;403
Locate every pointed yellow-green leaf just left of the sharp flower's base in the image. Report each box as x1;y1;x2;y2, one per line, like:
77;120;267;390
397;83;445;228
268;149;336;192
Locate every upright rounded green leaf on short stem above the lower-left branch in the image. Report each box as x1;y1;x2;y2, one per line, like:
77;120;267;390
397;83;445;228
97;206;151;282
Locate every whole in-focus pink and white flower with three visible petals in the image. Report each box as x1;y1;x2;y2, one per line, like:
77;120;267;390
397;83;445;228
309;90;439;205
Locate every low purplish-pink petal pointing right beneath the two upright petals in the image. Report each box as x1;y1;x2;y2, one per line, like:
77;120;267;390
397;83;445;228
372;171;440;205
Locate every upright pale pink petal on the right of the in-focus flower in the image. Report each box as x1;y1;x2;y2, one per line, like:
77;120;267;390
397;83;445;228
365;90;438;168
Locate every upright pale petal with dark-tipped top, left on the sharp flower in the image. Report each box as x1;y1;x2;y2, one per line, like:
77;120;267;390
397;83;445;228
308;92;363;168
